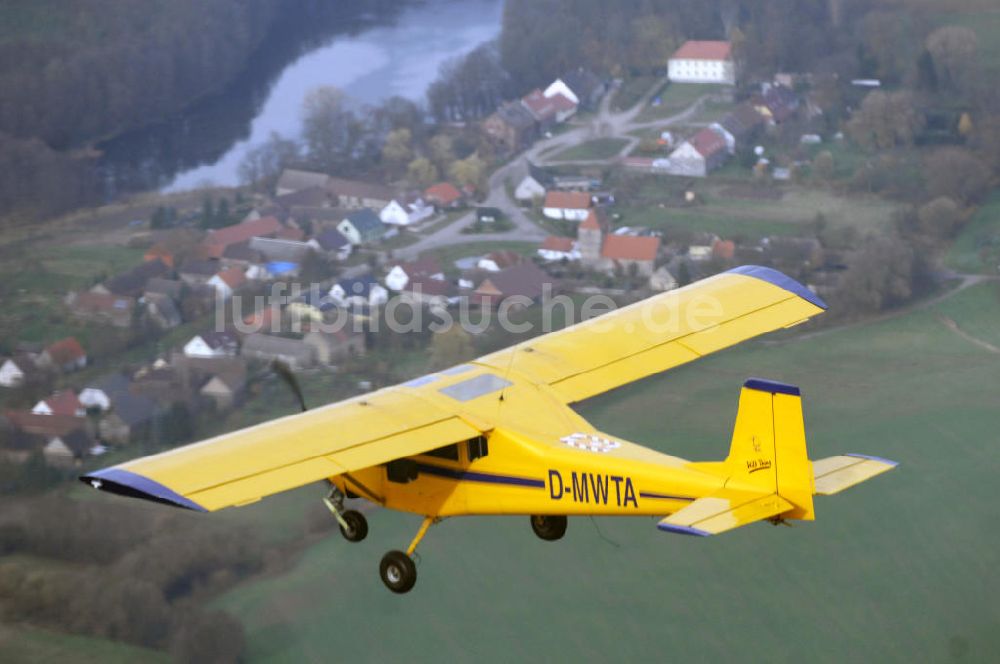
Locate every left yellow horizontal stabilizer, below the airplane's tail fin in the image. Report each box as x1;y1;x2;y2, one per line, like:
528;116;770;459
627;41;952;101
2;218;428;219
656;493;795;537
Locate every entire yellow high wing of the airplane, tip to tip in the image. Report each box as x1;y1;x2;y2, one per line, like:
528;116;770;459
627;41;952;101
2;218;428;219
81;266;825;511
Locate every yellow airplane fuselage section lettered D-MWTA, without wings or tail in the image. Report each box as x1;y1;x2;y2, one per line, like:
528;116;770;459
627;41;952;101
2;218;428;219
331;431;724;517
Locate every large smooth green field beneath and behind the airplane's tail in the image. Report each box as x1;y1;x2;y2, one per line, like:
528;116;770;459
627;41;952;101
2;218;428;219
217;285;1000;662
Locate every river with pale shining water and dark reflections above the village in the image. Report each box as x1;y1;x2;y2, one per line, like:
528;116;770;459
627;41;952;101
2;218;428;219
99;0;503;198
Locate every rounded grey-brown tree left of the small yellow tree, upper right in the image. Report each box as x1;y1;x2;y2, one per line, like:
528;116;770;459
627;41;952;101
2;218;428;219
847;90;926;150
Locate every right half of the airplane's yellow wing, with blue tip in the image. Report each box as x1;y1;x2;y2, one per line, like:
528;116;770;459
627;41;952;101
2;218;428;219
479;265;826;403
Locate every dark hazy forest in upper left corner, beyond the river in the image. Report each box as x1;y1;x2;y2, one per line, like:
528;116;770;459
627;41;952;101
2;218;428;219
0;0;404;222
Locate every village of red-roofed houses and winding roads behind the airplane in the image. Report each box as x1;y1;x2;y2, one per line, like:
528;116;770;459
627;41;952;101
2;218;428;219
0;41;960;468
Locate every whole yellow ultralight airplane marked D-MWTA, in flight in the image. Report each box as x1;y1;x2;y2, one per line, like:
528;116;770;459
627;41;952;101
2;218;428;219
81;266;896;593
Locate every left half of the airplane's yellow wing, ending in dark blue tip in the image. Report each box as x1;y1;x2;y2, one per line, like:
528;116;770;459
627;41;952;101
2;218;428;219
83;388;482;511
